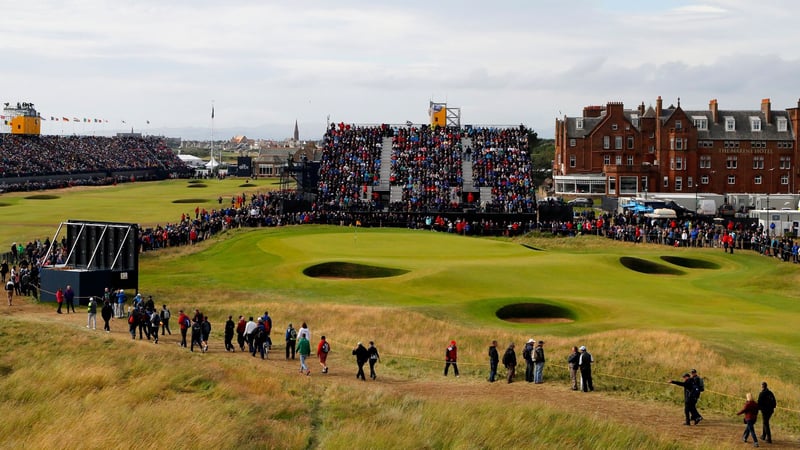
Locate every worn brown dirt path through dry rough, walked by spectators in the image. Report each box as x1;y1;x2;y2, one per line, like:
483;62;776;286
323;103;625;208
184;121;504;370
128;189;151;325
7;299;800;449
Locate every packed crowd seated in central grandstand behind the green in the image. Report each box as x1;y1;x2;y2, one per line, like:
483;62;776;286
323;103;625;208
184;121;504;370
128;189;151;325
318;123;536;213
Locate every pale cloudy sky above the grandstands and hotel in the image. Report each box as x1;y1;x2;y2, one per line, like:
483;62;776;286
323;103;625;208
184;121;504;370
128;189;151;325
0;0;800;140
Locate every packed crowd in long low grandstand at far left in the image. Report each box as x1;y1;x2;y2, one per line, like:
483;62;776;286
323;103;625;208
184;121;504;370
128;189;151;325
0;134;184;178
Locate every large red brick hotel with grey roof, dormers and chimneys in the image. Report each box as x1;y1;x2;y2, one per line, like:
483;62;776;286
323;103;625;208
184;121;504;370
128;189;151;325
553;96;800;196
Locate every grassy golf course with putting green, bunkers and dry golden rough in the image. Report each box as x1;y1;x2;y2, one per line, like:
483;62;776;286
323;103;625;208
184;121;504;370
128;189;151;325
0;179;800;449
